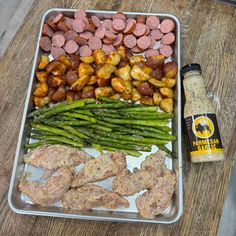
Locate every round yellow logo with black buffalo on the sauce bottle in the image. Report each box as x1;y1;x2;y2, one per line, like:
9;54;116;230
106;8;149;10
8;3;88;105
192;116;215;139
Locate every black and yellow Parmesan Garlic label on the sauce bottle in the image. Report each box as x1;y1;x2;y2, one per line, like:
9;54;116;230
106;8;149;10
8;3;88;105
185;114;223;156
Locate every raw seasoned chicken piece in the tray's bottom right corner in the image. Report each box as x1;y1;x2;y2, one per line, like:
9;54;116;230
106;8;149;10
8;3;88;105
136;170;176;218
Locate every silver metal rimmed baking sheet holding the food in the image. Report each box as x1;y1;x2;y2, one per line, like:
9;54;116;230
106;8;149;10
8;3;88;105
8;8;183;224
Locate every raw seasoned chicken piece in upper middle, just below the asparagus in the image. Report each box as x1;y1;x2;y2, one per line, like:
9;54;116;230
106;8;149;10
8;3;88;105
71;152;126;187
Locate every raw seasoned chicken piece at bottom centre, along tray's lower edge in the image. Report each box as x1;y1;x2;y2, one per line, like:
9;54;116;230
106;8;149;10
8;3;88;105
62;184;129;210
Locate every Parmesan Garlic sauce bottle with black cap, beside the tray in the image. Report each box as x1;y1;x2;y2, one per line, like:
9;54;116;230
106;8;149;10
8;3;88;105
181;64;225;162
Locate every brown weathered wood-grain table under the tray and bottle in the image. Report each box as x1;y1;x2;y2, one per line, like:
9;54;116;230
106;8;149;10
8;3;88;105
0;0;236;236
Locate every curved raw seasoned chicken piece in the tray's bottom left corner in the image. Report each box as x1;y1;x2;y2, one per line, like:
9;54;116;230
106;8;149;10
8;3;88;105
19;168;73;206
